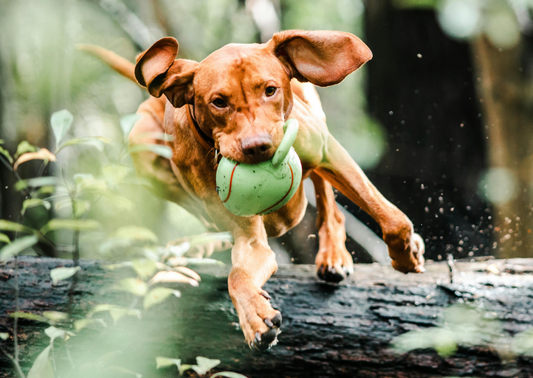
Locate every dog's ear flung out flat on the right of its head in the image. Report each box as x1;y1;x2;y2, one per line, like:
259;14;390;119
267;30;372;87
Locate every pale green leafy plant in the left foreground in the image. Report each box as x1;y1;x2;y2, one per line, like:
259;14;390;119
0;110;239;378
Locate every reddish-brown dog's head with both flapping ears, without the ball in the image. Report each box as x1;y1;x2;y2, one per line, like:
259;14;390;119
135;30;372;163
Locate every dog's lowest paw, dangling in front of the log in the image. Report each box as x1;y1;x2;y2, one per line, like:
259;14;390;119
234;290;282;352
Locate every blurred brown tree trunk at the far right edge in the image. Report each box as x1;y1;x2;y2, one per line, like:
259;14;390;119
472;37;533;258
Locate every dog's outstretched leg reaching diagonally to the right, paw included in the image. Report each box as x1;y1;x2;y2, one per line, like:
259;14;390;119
316;135;424;273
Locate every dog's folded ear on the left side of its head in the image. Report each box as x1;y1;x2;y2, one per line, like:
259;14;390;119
135;37;198;108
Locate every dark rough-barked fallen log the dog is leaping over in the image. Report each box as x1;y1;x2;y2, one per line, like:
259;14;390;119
0;257;533;378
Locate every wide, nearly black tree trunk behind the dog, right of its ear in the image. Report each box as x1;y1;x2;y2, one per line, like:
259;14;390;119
362;0;494;260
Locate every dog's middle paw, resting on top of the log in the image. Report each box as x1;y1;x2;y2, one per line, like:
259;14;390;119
315;245;353;283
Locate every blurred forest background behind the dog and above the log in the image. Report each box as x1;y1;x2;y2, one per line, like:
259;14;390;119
0;0;533;263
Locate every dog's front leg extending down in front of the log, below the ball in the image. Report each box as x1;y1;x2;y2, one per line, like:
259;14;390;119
228;216;281;352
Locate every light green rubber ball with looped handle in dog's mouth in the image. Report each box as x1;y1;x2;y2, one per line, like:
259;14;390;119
216;119;302;217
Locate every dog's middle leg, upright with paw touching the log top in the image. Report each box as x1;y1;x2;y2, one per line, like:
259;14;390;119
310;172;353;282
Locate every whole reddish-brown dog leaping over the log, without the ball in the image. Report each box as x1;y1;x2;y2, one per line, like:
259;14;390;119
84;30;424;351
